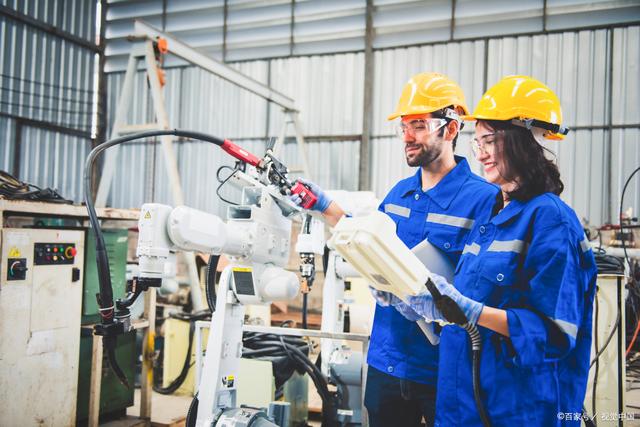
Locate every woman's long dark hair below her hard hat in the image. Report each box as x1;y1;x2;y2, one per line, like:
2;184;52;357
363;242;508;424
484;120;564;201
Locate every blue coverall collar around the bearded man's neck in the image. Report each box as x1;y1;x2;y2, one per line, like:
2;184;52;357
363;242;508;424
401;156;471;209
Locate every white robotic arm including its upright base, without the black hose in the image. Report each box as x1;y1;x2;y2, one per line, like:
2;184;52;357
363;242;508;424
137;185;300;426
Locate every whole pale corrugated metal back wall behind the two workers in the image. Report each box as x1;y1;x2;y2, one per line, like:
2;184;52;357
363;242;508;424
100;0;640;224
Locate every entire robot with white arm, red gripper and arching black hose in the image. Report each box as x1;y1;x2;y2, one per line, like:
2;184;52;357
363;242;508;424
85;130;324;426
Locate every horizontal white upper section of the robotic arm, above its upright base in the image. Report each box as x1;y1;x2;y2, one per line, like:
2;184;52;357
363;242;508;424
136;203;300;304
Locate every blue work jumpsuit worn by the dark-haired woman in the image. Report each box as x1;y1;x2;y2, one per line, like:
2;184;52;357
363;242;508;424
436;193;597;427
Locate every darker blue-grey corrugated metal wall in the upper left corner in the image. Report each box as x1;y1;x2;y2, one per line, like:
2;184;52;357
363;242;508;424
0;0;96;201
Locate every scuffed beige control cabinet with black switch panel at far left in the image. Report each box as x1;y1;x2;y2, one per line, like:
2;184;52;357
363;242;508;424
0;228;85;426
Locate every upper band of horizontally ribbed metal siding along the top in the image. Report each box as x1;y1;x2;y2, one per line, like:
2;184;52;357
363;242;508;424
102;0;640;71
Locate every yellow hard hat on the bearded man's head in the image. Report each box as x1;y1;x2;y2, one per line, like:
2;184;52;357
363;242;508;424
387;73;469;120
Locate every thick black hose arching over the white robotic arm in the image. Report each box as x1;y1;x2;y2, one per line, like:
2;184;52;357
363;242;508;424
84;129;224;384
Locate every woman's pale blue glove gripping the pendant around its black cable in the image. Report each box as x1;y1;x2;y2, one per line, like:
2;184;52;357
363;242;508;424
409;274;484;325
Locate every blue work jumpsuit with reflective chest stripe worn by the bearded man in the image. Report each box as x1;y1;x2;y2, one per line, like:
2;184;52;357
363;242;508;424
365;156;499;426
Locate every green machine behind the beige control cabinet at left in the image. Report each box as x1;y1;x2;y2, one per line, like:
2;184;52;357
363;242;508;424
76;229;137;425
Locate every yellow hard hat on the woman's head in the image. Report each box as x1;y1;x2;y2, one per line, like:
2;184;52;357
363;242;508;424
462;76;569;140
